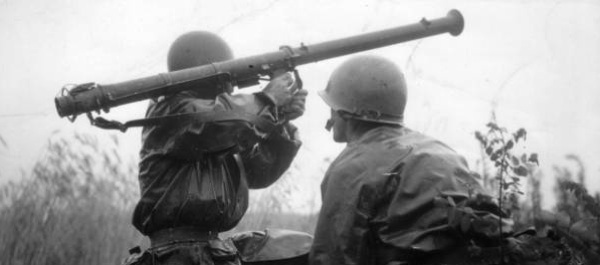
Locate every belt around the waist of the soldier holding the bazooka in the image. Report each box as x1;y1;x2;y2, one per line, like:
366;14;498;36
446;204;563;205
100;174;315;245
150;227;219;248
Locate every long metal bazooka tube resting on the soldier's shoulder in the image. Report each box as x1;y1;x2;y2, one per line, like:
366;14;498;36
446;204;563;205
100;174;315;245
55;10;464;124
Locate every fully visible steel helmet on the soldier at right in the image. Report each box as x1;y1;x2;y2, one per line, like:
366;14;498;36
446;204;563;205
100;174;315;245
319;55;406;125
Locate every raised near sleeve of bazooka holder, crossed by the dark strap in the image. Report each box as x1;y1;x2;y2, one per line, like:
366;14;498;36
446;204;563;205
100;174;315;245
144;93;284;160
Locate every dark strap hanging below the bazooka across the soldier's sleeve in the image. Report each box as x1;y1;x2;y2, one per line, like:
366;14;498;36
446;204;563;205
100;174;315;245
90;111;280;133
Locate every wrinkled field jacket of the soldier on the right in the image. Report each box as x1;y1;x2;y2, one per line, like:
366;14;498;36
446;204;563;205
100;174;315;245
310;126;492;265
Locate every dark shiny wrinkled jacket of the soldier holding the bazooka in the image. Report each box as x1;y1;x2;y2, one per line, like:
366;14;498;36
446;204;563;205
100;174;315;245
133;92;300;235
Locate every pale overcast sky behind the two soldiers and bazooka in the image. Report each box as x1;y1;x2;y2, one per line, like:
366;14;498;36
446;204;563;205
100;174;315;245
0;0;600;210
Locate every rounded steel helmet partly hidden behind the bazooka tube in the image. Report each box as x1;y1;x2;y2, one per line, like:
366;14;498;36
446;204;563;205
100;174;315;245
167;31;233;71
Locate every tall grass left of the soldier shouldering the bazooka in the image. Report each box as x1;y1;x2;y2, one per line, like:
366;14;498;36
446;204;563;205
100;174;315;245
0;134;142;265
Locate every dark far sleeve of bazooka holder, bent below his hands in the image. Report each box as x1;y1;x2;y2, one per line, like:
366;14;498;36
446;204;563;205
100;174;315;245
243;123;301;189
